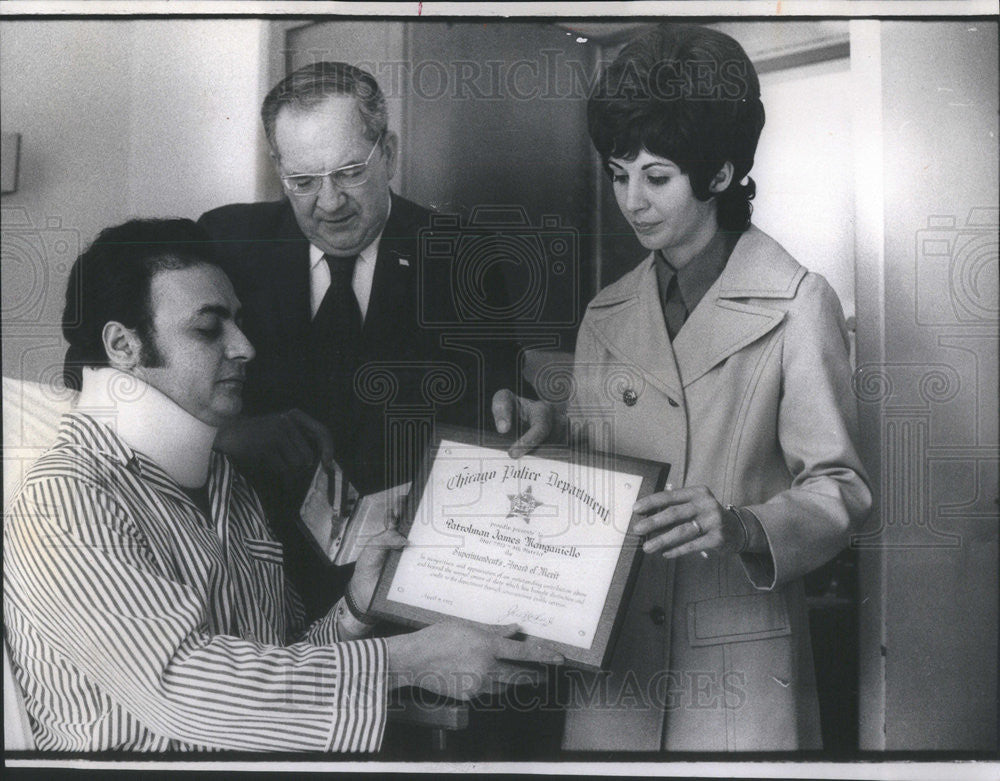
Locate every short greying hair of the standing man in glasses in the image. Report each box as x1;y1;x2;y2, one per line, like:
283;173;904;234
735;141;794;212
260;62;389;152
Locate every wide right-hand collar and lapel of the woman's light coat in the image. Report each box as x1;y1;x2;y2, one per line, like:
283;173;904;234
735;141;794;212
673;227;806;386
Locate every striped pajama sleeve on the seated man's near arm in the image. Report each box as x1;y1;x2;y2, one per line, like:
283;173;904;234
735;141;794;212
4;476;387;751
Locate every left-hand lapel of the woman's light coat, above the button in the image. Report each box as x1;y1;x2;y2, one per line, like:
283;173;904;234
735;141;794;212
590;255;683;399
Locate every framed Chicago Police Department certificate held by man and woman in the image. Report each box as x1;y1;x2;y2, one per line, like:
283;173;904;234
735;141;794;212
370;426;669;669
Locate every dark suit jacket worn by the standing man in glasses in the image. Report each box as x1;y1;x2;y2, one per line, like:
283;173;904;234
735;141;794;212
199;194;516;609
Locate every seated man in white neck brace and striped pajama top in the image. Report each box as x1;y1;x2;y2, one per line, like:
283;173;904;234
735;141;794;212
3;220;561;751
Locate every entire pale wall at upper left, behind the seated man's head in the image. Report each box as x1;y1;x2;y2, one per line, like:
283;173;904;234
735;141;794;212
0;19;269;379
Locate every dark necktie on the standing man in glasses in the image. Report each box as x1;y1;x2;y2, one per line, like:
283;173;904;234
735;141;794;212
310;255;361;427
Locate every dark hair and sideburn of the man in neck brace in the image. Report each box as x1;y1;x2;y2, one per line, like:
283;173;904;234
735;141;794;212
62;219;217;390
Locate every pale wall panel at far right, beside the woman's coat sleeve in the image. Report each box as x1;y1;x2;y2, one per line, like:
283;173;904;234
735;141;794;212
853;20;1000;752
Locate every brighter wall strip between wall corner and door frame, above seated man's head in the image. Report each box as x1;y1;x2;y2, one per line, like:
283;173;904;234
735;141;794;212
128;19;269;217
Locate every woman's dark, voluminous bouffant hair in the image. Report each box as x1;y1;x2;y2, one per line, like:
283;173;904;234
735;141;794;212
587;24;764;231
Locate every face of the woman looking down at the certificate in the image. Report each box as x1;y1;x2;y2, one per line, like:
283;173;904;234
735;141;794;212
608;149;718;268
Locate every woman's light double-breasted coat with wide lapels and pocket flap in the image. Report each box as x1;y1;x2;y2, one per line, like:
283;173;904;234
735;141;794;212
563;227;871;751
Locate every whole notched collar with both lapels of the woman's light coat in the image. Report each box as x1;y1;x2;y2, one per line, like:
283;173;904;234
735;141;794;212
590;226;806;398
